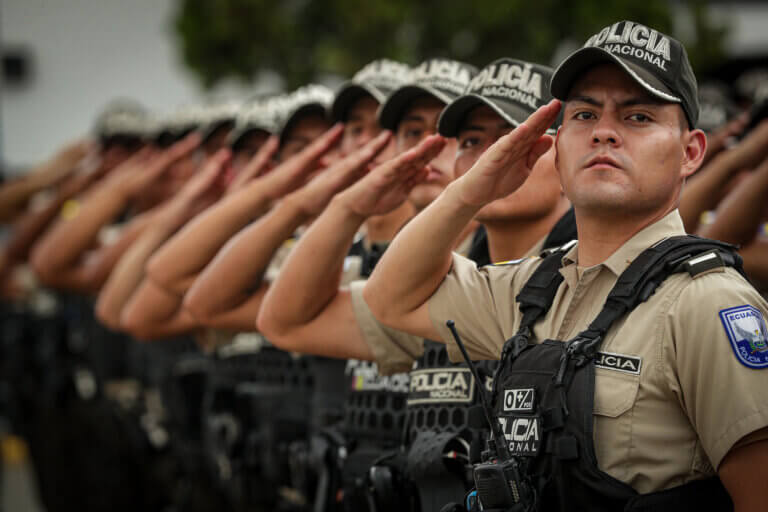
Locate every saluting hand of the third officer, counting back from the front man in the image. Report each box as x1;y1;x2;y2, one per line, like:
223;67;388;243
291;131;392;216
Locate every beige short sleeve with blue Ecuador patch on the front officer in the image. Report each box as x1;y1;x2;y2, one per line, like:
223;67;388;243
665;269;768;468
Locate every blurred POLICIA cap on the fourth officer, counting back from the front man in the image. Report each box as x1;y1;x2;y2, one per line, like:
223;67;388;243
331;59;411;121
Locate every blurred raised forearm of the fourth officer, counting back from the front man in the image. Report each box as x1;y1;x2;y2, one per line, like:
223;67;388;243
147;181;272;289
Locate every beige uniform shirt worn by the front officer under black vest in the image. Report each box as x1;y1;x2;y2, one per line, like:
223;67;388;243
428;211;768;493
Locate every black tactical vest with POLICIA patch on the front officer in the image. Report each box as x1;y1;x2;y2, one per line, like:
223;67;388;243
449;236;741;512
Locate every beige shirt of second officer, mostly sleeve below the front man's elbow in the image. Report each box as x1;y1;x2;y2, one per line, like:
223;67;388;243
349;230;546;375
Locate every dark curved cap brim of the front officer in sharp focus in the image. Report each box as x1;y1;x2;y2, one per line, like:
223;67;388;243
550;46;682;103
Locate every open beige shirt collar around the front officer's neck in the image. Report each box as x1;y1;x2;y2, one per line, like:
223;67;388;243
563;209;685;276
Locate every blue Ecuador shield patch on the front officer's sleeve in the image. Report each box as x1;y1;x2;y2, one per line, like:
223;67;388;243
720;305;768;369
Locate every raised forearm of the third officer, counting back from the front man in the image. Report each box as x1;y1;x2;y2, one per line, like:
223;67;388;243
184;201;307;323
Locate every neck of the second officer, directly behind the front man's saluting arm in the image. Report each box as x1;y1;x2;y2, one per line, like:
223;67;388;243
483;199;570;263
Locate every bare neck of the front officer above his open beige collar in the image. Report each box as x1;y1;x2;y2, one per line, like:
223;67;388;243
575;208;669;268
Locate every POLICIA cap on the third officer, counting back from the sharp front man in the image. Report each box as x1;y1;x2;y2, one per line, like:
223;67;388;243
379;59;477;130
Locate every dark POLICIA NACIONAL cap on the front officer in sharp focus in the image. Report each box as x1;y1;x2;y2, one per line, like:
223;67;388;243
551;21;699;128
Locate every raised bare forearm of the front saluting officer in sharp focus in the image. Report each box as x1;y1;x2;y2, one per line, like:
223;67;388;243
364;179;481;327
